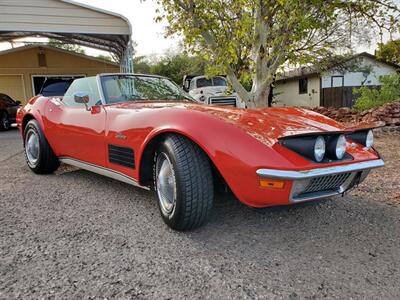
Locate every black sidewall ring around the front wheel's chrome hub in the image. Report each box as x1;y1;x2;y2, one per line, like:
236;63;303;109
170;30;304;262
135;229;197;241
153;139;184;228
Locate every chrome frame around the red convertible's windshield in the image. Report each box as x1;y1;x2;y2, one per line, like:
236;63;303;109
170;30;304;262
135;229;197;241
96;73;195;104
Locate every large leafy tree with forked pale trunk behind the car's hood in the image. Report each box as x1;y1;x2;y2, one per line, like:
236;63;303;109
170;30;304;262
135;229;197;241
156;0;399;107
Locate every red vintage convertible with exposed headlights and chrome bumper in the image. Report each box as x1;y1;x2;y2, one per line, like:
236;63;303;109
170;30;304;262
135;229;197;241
17;74;384;230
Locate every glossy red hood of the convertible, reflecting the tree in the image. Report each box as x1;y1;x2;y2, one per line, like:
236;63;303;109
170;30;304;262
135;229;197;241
108;102;348;146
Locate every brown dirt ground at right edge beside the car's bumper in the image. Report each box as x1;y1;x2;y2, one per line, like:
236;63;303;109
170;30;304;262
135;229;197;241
350;133;400;206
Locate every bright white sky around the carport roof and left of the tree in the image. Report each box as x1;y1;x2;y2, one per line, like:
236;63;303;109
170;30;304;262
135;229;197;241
0;0;400;56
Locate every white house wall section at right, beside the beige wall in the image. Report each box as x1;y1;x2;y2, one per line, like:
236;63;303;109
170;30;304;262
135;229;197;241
321;56;396;88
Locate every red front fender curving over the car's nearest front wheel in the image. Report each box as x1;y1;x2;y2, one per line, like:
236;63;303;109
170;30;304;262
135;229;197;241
133;109;291;206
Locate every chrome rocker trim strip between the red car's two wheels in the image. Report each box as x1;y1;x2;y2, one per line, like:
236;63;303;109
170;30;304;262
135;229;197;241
59;157;150;190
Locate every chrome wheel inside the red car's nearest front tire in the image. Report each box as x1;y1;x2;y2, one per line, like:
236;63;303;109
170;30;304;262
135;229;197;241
156;152;176;217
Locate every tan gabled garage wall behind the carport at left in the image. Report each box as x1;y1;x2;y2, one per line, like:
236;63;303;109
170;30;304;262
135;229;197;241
0;47;119;103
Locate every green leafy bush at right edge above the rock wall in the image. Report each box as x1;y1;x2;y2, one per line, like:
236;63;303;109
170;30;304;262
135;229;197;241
353;74;400;111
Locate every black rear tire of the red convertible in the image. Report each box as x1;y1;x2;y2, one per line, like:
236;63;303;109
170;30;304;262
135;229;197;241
24;120;60;174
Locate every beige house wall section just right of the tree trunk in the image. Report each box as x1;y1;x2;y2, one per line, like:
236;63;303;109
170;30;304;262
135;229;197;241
273;75;320;107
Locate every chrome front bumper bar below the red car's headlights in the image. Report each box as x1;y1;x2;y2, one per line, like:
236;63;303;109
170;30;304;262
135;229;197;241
257;159;385;180
